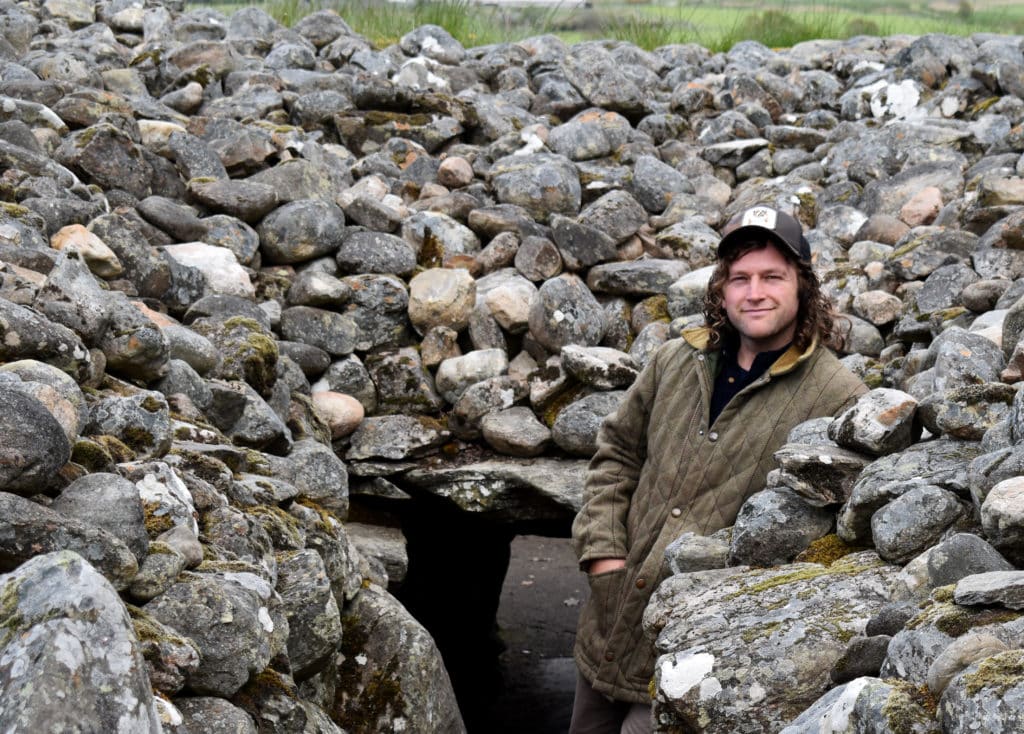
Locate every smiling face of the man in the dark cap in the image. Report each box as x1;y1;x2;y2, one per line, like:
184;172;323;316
723;245;800;355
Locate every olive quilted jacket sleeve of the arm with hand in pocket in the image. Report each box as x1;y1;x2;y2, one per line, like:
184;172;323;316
572;339;666;566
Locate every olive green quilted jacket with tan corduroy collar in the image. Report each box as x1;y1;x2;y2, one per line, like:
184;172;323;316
572;328;867;703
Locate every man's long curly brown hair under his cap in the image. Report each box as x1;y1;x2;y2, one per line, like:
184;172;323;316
703;240;851;350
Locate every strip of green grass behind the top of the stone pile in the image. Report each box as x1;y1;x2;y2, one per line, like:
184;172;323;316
192;0;1024;51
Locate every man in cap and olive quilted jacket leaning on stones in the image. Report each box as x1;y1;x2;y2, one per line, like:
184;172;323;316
569;206;867;734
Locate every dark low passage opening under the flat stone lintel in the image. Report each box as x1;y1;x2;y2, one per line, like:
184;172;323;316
397;498;586;734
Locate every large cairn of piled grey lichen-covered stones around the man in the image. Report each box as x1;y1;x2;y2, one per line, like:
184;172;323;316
0;0;1024;734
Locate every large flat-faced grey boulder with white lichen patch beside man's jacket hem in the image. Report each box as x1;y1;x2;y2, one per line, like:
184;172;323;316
643;553;894;732
